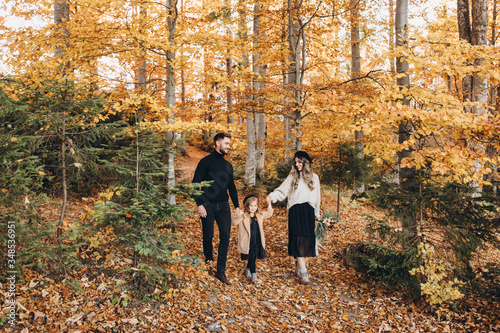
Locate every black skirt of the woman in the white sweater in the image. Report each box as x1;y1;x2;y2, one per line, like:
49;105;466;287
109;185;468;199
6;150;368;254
288;203;316;257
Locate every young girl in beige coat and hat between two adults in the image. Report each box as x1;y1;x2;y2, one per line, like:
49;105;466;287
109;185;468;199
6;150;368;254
233;194;273;282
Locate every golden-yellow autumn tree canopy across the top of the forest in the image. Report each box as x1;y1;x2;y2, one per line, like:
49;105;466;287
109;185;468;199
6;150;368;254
1;0;498;213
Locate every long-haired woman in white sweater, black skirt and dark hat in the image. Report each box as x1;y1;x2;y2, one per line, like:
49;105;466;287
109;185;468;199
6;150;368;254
267;151;321;284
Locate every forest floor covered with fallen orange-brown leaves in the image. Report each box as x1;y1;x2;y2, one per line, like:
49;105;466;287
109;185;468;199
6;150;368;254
2;150;500;333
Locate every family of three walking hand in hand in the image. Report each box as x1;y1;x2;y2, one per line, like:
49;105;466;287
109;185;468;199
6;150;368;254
193;133;321;285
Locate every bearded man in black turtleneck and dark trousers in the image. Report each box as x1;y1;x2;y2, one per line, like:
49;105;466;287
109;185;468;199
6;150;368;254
193;133;240;285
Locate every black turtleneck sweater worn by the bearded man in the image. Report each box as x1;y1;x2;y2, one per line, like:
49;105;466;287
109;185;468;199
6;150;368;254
193;151;240;208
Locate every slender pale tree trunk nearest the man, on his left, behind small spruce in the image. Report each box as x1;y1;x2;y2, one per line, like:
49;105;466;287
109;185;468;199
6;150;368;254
165;0;177;205
